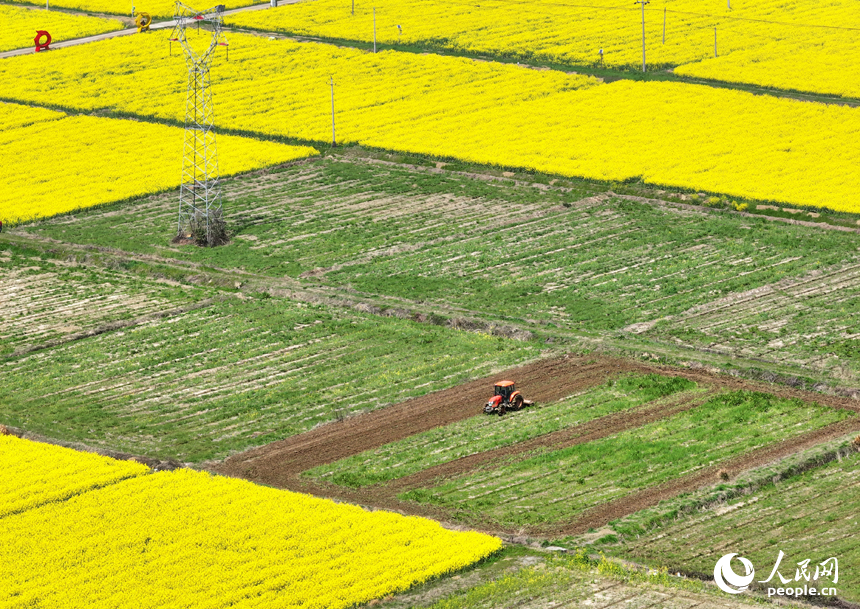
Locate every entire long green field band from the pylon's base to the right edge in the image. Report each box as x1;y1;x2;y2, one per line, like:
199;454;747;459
16;159;860;383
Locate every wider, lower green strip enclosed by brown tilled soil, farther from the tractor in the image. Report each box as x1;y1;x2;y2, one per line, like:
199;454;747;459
401;391;856;525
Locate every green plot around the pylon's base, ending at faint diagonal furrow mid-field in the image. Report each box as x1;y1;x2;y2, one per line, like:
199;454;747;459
16;159;606;277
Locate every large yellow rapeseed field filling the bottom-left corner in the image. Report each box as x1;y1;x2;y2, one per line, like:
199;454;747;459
0;458;501;609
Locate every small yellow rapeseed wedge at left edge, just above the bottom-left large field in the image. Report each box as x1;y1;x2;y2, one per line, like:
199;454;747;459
0;436;149;516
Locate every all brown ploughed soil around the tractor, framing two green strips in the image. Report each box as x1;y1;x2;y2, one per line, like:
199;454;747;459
211;355;860;536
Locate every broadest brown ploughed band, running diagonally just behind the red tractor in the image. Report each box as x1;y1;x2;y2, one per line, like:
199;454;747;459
213;356;637;486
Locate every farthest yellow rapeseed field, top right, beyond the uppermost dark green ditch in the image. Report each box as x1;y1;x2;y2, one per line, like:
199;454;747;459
228;0;860;96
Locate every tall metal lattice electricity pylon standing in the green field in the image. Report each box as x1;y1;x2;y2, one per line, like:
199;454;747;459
170;2;226;247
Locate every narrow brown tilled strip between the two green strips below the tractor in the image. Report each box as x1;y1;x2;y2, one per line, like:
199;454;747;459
385;389;715;494
